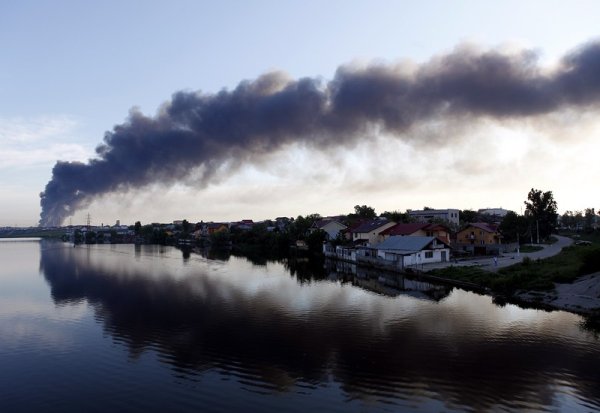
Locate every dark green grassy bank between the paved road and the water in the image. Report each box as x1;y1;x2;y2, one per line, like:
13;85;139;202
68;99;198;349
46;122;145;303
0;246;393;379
431;245;600;295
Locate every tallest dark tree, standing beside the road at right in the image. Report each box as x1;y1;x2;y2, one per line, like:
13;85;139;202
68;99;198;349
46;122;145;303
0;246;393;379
525;188;558;239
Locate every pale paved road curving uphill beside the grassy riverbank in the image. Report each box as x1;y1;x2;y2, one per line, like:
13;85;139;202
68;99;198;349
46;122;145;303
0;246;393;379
424;235;573;271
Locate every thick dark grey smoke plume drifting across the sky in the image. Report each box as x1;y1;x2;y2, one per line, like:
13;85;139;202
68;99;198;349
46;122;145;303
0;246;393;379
40;42;600;226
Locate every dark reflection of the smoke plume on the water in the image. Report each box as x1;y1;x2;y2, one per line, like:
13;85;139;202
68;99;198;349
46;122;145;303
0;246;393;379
40;243;600;410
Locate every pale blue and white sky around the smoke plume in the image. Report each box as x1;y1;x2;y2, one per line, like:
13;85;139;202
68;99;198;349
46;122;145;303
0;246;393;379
0;0;600;226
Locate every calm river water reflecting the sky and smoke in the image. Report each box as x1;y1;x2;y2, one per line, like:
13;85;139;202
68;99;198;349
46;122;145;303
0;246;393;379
0;240;600;412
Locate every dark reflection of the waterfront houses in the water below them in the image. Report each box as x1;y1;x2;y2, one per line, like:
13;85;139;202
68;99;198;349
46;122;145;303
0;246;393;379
325;259;453;301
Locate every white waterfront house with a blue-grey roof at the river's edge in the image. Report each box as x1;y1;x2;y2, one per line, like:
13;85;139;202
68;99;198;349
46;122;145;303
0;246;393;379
376;235;450;268
